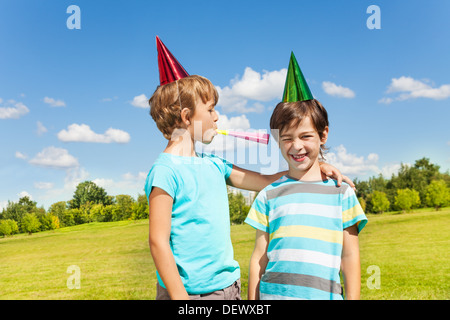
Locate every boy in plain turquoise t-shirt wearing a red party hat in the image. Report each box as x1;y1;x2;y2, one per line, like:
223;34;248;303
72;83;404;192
145;38;350;299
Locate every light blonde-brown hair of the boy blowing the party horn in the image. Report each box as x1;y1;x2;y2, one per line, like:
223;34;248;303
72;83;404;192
149;75;219;140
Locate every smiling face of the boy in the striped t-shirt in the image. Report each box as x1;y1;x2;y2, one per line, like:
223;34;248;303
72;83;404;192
279;117;328;177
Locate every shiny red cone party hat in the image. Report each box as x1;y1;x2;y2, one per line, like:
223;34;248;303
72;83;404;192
156;36;189;86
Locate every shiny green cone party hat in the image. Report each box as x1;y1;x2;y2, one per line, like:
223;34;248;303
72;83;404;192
283;52;314;102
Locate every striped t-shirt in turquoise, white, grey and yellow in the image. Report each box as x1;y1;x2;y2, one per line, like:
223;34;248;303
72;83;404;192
245;176;367;300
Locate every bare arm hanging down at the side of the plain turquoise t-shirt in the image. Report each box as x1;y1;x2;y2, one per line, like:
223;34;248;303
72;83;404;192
149;187;189;300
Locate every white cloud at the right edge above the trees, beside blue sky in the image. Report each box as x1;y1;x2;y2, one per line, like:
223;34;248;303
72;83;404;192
378;76;450;104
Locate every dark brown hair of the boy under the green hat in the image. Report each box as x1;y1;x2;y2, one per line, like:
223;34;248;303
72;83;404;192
270;99;329;158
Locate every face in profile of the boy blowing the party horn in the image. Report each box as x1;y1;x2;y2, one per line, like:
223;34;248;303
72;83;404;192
188;98;219;144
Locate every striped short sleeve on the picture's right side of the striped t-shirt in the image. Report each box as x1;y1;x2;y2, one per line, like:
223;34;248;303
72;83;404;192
342;187;367;232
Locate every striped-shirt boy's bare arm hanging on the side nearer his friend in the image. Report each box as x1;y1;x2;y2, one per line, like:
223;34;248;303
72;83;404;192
248;230;269;300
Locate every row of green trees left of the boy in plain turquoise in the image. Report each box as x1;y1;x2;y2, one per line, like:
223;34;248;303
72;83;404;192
0;181;148;236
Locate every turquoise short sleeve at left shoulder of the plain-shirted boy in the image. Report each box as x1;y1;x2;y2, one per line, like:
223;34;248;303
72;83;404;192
145;165;177;199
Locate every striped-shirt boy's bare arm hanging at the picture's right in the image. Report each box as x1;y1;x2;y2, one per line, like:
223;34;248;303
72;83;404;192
341;225;361;300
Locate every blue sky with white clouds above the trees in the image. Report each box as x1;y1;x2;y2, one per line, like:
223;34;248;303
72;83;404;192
0;0;450;208
